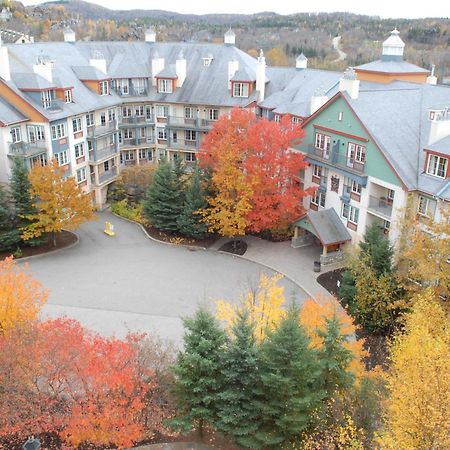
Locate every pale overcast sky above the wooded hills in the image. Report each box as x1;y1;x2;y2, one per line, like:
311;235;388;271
23;0;450;18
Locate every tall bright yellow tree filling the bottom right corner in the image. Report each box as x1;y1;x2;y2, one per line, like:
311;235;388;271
378;289;450;450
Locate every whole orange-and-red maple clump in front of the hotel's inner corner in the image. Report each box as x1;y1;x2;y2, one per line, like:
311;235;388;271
199;108;312;234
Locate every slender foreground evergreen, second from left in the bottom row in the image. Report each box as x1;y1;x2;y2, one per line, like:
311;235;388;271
214;310;260;448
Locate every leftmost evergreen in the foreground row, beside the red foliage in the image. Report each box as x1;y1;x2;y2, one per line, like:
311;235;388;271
171;308;226;436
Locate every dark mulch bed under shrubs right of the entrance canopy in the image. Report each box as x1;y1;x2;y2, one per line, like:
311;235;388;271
317;268;389;369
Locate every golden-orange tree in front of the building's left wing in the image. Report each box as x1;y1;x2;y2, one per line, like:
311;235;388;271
22;160;94;245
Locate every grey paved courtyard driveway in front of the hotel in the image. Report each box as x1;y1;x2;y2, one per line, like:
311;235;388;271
21;212;307;344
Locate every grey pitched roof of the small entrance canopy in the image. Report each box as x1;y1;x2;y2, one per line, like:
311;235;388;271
294;208;352;245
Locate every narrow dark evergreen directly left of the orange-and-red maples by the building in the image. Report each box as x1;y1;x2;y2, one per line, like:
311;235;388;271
178;168;208;239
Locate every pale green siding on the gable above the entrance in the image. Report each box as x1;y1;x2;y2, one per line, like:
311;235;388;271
297;98;402;186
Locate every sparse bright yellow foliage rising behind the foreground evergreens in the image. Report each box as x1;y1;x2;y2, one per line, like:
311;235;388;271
217;274;286;342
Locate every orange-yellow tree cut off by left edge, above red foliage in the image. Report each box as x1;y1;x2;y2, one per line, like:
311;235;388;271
0;257;48;334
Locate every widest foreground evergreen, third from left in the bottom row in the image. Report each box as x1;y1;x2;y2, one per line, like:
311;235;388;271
249;308;325;449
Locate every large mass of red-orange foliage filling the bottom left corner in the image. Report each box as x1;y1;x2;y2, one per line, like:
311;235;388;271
0;319;155;448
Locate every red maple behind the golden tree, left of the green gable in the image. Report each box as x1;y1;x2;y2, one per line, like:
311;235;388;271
199;109;313;232
